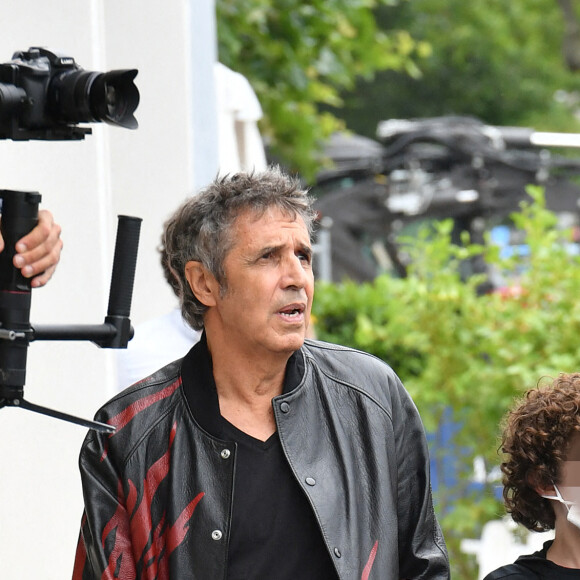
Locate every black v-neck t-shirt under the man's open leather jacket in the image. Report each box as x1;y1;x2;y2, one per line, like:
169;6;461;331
224;420;337;580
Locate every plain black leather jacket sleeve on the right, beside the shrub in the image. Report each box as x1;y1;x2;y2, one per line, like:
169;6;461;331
392;378;450;580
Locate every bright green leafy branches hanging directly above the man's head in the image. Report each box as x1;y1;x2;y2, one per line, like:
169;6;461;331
216;0;426;178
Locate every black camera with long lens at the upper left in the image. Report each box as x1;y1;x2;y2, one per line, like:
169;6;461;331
0;47;139;140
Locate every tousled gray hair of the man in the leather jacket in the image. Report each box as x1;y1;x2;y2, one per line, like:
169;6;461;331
160;166;316;330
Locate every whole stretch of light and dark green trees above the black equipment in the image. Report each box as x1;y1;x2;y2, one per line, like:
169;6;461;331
216;0;580;181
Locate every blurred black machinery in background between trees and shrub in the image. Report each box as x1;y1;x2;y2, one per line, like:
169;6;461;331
312;116;580;282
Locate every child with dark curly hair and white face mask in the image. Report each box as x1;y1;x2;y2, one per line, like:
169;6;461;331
485;373;580;580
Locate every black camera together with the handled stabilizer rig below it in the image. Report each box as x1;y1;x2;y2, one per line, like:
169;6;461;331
0;47;141;433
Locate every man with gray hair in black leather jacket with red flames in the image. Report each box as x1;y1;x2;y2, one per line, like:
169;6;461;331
73;167;449;580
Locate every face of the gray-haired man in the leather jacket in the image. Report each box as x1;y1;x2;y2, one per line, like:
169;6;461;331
208;208;314;355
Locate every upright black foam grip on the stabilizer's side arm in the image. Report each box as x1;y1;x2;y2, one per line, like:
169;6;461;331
107;215;142;317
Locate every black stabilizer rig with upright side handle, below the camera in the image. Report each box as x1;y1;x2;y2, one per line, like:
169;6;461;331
0;190;141;433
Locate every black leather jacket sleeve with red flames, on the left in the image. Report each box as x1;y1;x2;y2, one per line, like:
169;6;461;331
73;432;136;580
